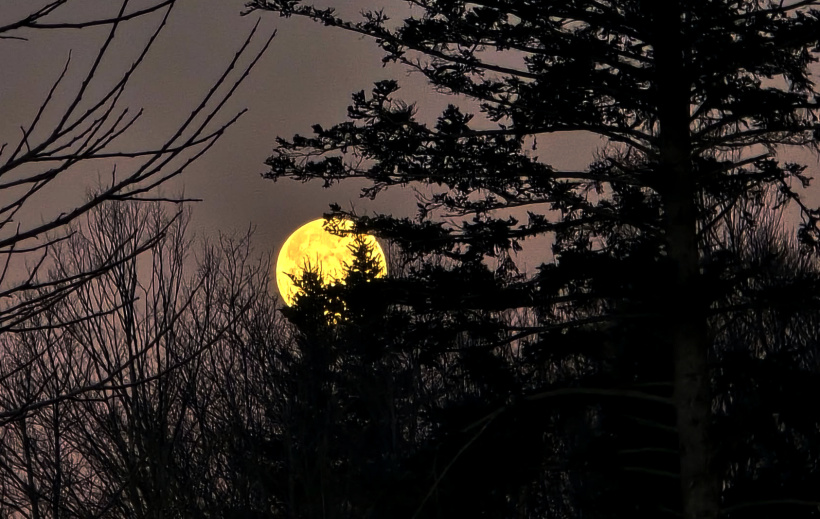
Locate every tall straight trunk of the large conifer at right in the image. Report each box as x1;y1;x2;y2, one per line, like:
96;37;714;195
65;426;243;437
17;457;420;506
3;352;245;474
648;4;719;519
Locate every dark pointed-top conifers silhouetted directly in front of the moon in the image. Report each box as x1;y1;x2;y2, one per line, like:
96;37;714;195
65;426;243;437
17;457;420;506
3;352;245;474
282;229;421;518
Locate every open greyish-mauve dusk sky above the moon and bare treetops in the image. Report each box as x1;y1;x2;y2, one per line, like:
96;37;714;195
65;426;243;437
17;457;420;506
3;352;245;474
0;0;816;280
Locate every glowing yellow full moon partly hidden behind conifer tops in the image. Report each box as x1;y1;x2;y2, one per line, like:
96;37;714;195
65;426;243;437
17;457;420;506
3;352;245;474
276;218;387;306
